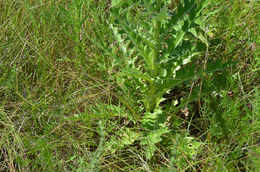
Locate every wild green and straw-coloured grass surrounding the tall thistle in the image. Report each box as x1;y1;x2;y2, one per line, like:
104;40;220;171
0;0;260;172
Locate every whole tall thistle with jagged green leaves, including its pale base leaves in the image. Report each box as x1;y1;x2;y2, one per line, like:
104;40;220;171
93;0;230;159
